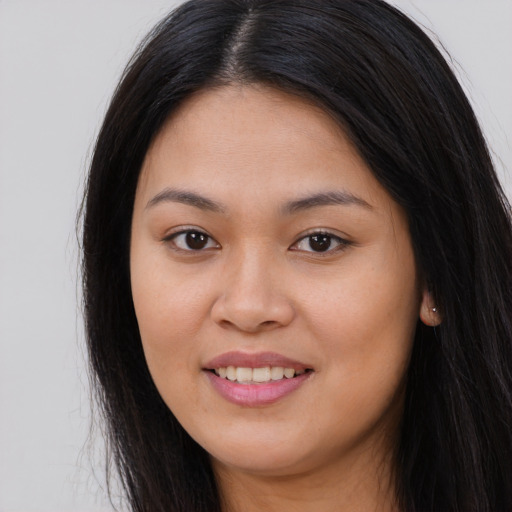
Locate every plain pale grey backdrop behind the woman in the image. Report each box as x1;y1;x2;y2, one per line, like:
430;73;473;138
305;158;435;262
0;0;512;512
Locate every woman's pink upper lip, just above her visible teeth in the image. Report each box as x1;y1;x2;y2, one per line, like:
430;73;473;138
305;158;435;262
204;351;312;370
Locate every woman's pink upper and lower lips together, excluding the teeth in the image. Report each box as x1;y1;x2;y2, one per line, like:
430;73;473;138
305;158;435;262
204;351;313;407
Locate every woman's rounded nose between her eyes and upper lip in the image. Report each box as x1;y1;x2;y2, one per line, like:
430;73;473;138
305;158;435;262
211;250;295;333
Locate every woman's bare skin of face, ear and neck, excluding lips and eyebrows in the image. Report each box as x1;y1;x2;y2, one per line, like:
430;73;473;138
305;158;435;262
130;85;438;512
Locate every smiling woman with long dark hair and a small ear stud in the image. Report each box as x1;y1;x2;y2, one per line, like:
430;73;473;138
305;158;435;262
80;0;512;512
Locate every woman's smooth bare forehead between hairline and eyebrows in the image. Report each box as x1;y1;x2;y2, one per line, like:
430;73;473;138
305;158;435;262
138;85;396;212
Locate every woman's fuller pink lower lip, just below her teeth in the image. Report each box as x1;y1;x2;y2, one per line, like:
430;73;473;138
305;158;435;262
205;371;313;407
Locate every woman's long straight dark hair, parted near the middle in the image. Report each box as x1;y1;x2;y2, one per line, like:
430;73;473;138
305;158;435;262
83;0;512;512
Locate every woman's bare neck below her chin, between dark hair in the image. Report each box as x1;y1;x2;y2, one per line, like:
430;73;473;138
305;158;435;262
213;436;399;512
